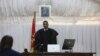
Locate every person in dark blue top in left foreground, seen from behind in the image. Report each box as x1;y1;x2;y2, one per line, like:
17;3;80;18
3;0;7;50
0;35;22;56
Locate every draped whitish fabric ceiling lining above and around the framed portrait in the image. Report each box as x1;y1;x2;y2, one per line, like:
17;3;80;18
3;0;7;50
0;0;100;17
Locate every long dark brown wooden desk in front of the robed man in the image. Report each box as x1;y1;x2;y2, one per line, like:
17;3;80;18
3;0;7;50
24;52;96;56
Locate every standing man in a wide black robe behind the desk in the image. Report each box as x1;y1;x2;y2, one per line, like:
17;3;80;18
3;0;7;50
34;21;58;52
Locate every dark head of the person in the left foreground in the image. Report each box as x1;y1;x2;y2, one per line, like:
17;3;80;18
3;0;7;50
0;35;13;48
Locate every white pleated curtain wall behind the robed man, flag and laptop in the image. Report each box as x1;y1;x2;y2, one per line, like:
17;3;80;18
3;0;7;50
0;17;100;56
